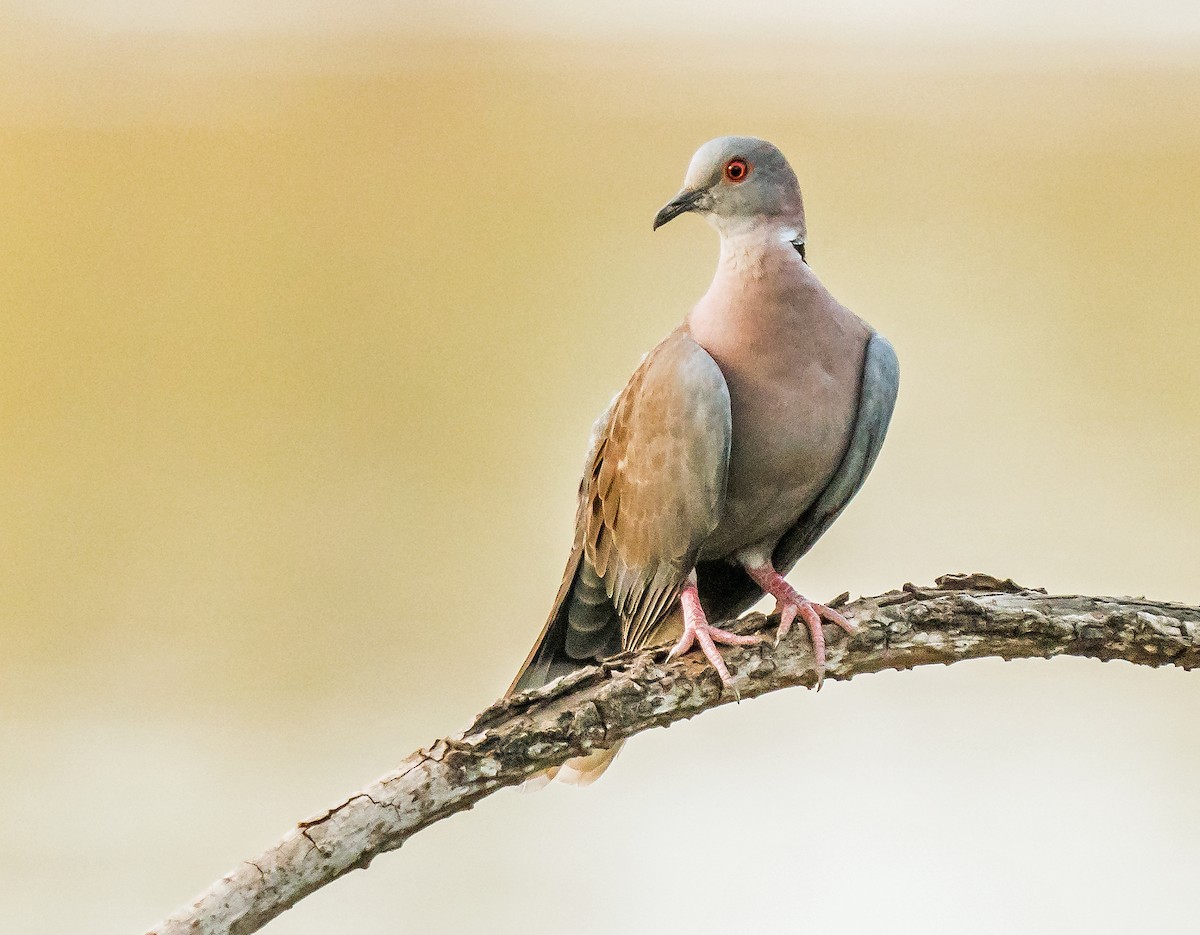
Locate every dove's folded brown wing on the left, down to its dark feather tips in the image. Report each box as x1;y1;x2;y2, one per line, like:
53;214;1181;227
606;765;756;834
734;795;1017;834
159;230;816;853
509;329;731;693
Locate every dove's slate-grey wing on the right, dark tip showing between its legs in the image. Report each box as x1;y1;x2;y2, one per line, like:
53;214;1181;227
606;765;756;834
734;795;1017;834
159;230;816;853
698;332;900;619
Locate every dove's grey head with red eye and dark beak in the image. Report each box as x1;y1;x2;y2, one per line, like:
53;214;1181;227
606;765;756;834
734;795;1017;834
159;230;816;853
654;137;804;238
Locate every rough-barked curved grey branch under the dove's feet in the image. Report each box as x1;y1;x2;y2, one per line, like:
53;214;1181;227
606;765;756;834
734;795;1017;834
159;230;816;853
151;575;1200;935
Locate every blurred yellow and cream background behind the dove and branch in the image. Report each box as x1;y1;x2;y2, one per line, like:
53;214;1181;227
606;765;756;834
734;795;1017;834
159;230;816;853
0;0;1200;935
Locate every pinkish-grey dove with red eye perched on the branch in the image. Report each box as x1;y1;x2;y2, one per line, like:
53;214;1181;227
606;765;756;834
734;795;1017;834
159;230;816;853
506;136;900;785
